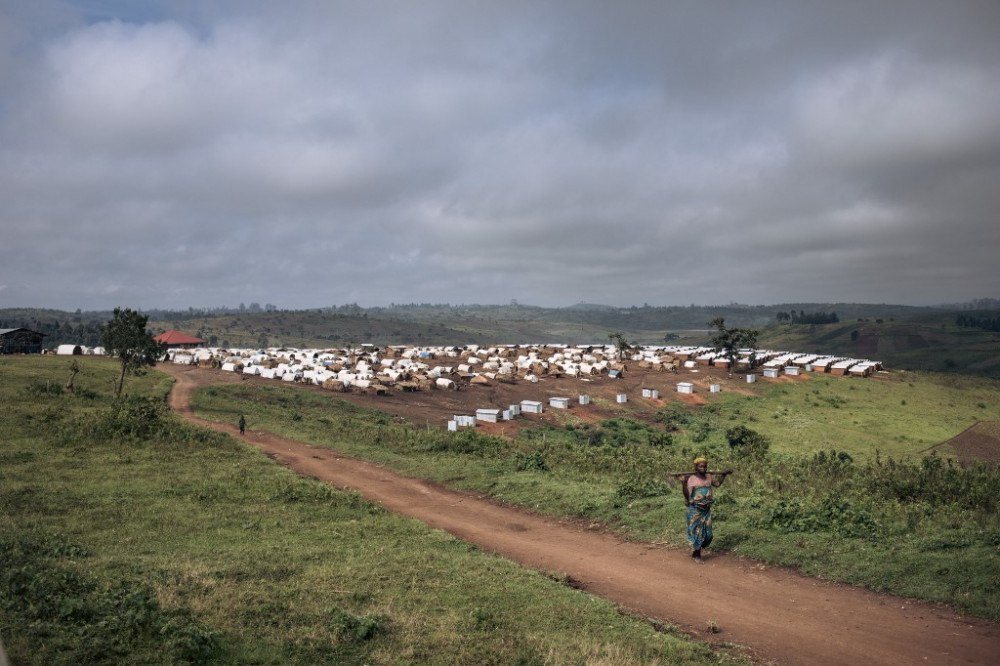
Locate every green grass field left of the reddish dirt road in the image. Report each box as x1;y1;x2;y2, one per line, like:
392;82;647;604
0;357;740;664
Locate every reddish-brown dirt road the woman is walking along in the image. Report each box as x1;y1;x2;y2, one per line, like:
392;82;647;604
160;364;1000;664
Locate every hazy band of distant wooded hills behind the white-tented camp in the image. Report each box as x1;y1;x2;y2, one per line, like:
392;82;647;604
0;302;1000;376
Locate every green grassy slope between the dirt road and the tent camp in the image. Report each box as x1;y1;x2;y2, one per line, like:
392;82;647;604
189;366;1000;619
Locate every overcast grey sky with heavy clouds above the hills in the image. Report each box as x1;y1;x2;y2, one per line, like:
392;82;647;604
0;0;1000;309
